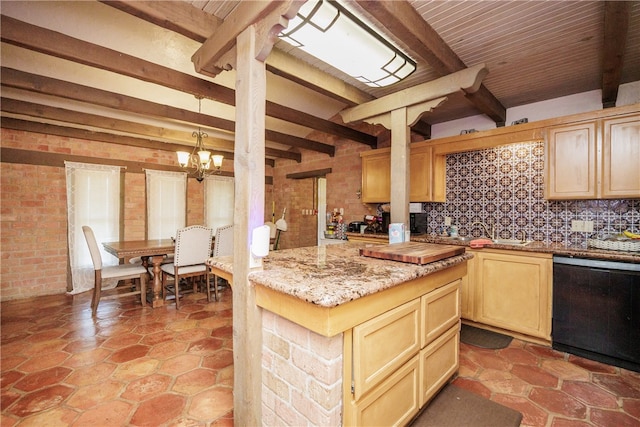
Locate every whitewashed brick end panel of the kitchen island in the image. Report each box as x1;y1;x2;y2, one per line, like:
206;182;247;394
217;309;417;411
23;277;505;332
262;310;343;426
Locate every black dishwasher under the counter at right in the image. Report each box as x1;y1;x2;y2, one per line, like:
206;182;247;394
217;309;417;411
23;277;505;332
551;256;640;372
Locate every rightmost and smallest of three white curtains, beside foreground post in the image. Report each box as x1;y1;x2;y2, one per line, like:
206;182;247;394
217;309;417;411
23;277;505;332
204;176;235;234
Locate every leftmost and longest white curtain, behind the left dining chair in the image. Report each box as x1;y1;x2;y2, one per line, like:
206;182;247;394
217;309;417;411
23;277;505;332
65;162;120;294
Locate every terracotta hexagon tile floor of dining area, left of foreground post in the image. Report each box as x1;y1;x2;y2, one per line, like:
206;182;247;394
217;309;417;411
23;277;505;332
0;288;233;427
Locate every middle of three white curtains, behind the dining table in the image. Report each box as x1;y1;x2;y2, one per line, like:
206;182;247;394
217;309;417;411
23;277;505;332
145;169;187;239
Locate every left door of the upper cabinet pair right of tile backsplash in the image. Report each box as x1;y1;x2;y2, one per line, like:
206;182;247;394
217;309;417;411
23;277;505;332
545;122;597;200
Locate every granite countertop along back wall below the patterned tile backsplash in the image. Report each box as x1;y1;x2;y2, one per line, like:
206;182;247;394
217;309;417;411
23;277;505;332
347;233;640;263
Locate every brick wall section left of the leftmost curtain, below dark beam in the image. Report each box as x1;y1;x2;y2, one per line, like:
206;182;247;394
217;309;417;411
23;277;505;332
0;163;67;300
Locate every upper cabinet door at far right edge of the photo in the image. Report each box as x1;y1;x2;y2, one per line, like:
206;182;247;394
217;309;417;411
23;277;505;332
602;115;640;199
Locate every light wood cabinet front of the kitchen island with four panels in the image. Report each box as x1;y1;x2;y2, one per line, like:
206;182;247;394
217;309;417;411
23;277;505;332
343;279;461;426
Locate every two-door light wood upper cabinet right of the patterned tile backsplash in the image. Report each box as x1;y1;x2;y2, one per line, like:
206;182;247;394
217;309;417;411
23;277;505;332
545;114;640;200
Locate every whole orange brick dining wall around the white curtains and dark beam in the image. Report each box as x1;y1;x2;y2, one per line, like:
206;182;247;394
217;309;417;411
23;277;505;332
0;129;210;301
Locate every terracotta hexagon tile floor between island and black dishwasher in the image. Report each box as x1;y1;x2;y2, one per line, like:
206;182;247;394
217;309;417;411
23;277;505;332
454;339;640;427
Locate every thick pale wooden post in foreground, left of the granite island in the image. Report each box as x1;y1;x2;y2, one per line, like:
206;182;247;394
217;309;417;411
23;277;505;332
233;26;266;426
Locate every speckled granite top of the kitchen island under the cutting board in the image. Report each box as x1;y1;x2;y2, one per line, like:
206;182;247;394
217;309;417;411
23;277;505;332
208;241;473;308
